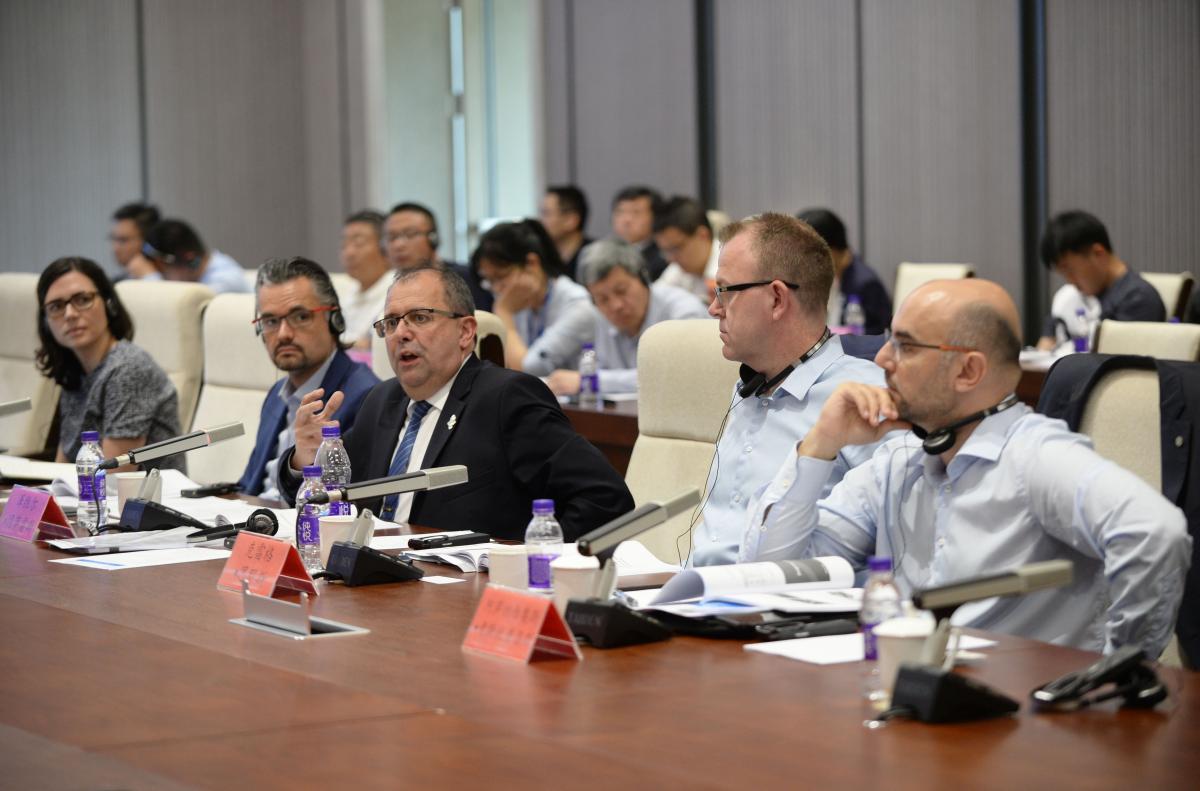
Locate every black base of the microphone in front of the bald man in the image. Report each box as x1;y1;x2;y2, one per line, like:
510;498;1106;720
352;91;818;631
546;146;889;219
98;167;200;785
883;663;1021;723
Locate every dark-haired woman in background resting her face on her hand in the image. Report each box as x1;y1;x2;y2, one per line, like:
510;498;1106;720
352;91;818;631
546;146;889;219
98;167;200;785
470;220;595;376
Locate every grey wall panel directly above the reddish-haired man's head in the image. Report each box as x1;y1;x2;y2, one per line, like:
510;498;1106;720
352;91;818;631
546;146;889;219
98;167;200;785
715;0;862;238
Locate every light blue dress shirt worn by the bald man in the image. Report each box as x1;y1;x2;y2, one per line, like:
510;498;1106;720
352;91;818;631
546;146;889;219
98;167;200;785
743;405;1192;657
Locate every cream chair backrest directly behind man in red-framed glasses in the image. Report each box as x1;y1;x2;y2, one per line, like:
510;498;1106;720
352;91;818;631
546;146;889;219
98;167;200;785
187;294;281;484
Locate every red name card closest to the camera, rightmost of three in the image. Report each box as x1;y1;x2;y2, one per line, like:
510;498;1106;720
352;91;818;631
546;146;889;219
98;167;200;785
462;586;583;661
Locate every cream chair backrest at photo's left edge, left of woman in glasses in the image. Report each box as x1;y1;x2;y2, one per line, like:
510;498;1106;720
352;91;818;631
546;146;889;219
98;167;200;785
0;272;60;455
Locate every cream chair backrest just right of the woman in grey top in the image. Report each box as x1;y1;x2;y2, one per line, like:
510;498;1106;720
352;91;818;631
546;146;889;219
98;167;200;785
116;280;212;432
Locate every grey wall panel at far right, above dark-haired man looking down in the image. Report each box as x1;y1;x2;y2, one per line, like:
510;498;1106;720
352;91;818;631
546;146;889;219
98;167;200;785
1046;0;1200;277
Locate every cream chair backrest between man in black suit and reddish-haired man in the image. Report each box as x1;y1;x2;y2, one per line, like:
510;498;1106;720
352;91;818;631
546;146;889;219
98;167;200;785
625;319;738;563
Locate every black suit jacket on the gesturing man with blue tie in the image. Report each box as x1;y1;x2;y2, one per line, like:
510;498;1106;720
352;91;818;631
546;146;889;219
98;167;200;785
280;355;634;541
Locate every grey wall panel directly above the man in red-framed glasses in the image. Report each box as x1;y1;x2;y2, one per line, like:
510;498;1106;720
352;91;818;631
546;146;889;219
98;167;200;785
145;0;309;268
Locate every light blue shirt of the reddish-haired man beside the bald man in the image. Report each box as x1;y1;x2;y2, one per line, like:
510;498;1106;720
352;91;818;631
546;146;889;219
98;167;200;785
691;335;883;565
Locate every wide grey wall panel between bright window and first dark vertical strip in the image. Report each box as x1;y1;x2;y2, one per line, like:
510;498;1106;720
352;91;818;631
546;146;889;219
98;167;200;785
566;0;698;235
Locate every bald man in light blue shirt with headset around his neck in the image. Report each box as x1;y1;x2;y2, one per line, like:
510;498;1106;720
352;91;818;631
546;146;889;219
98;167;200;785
742;280;1192;658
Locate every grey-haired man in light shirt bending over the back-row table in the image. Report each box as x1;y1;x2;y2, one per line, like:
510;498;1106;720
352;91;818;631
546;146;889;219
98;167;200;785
547;239;708;395
